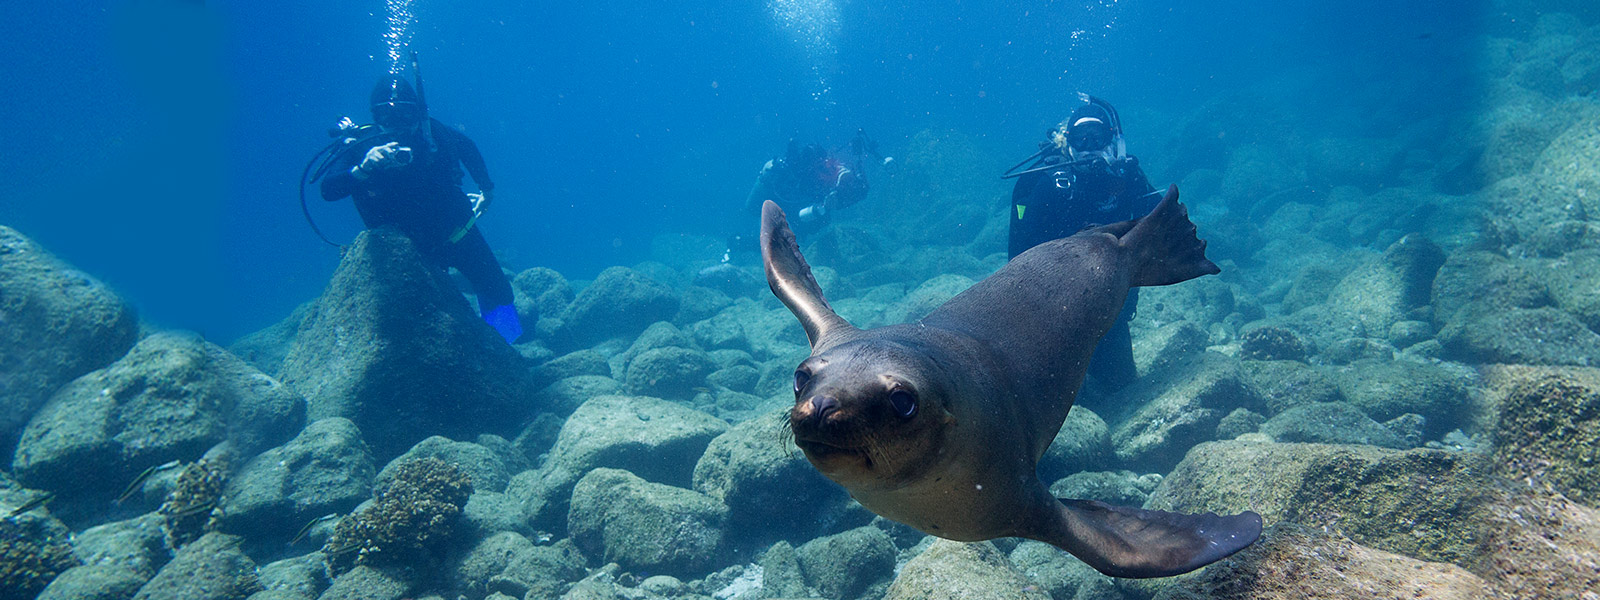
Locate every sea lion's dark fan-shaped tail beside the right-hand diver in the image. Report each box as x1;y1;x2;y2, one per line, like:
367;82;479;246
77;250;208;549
1120;186;1222;286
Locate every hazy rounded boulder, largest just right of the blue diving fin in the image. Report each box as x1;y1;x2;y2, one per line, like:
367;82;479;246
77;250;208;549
554;267;678;349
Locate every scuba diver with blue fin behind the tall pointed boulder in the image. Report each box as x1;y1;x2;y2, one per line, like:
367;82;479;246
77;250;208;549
322;77;522;342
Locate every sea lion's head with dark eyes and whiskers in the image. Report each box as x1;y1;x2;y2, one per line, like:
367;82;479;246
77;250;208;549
789;339;954;486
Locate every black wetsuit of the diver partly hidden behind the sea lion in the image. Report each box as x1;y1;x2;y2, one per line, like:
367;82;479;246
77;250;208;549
1010;157;1162;390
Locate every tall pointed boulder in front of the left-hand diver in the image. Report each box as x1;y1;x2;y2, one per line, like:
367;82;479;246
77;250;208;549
282;229;531;458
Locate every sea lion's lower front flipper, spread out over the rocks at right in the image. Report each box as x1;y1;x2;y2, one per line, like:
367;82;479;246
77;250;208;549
1045;498;1261;578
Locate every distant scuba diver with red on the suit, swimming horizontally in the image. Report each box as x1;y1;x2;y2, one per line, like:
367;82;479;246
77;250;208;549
744;130;894;241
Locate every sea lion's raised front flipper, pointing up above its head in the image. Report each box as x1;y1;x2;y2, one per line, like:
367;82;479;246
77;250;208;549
762;200;854;350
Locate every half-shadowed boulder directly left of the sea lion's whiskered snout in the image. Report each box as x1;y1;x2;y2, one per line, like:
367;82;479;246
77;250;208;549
694;413;850;541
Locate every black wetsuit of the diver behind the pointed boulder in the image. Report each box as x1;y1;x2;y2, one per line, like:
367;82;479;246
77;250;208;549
322;118;514;312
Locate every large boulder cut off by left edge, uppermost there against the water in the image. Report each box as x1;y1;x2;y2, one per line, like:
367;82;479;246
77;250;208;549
0;226;139;445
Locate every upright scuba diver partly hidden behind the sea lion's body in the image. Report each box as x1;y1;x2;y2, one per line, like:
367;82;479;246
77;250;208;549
1002;93;1162;392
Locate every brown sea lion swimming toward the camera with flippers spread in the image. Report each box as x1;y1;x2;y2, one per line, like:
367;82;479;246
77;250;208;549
762;186;1261;578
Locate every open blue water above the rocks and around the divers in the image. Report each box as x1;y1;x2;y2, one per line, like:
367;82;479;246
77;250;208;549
0;0;1472;341
